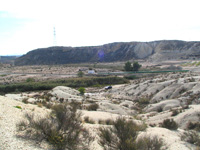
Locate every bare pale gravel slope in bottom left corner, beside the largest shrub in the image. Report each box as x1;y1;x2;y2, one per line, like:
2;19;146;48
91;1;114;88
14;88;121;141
0;96;46;150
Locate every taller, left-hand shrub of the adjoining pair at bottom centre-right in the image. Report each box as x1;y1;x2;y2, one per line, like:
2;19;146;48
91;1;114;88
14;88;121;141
98;118;145;150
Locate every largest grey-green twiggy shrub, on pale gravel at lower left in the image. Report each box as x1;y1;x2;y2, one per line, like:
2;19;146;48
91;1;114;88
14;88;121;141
17;104;91;150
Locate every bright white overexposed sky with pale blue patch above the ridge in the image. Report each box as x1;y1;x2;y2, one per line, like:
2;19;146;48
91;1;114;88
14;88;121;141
0;0;200;55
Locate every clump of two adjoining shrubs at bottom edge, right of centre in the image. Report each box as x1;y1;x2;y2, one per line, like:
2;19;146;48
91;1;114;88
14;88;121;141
99;118;164;150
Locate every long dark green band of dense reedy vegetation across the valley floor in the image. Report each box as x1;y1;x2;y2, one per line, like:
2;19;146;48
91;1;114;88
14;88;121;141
0;77;129;94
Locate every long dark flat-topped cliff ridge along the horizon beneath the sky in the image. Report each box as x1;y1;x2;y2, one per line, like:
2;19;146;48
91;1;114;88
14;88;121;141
15;41;200;65
